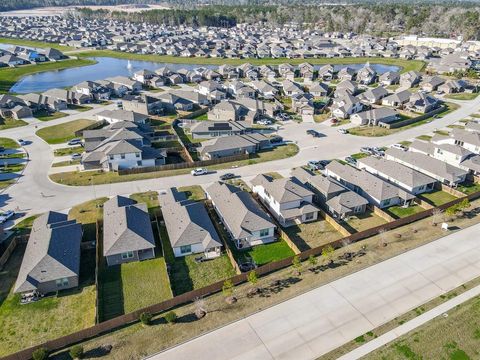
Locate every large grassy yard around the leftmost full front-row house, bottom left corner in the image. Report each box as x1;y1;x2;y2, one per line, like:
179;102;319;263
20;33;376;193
0;245;95;356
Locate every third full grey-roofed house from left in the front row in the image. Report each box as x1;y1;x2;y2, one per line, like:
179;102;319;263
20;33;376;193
158;188;222;259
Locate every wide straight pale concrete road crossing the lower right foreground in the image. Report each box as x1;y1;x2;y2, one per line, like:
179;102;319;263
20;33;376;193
146;225;480;360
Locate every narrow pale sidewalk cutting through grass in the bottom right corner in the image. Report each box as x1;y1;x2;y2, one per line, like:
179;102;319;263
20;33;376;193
338;285;480;360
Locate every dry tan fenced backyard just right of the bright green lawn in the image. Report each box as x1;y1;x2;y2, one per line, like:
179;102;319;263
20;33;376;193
283;219;342;251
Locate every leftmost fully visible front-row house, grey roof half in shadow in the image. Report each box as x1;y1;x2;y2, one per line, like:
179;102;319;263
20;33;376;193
14;211;82;294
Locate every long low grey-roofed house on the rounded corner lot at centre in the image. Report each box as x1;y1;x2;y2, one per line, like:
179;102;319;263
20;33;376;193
197;133;270;160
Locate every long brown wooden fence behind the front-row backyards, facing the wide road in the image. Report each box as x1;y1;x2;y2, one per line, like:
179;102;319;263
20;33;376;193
2;192;480;360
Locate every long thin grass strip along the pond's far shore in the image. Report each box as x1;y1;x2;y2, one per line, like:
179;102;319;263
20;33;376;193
76;50;426;72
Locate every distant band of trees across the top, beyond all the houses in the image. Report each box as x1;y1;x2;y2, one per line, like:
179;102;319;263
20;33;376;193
0;0;480;40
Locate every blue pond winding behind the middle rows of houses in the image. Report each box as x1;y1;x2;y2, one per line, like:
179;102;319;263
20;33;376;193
5;49;399;94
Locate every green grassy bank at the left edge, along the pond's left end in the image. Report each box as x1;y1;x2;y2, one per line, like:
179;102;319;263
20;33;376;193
0;59;95;94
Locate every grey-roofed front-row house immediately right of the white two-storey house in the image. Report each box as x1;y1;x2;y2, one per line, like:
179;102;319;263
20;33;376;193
292;168;368;219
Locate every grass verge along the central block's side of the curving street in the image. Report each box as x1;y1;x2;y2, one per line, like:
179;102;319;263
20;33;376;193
48;143;298;186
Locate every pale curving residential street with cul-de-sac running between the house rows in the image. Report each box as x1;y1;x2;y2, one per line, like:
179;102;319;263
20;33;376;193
0;97;480;214
